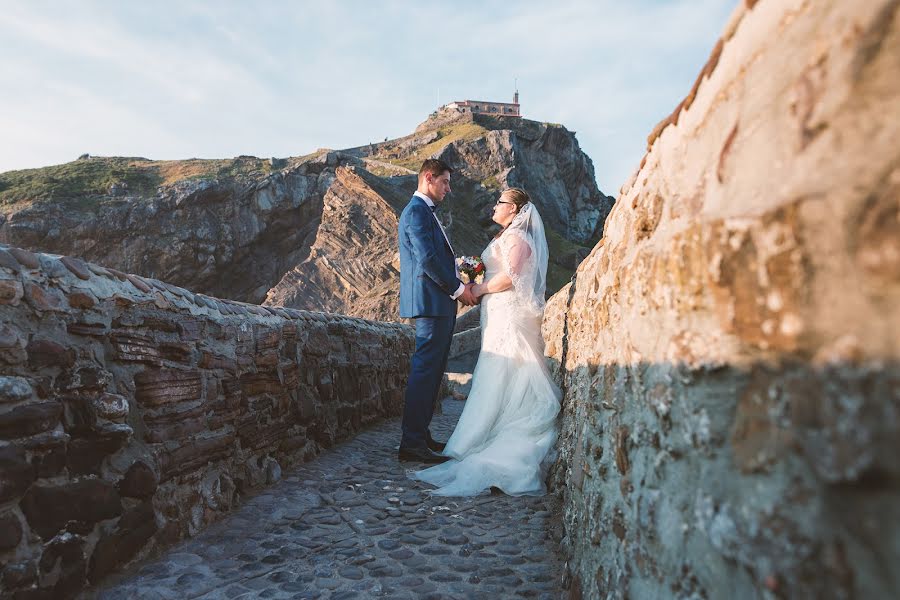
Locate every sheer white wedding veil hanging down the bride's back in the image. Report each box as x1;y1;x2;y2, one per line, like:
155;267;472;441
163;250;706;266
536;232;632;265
501;202;549;317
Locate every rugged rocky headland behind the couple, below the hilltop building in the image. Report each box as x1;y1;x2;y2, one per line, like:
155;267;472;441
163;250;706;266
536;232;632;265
0;112;612;320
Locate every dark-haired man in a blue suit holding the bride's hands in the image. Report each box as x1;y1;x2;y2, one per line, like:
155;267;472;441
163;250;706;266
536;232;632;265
397;158;478;464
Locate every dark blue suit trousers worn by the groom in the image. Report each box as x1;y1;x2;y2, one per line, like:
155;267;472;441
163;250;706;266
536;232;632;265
400;315;456;448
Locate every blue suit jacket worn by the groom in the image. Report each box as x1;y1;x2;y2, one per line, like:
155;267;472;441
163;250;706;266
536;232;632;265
399;196;462;318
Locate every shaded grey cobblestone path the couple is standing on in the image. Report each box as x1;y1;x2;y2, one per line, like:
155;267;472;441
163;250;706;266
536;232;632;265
84;399;562;600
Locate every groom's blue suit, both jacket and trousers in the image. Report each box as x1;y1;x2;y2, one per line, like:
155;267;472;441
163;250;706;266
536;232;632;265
398;196;462;448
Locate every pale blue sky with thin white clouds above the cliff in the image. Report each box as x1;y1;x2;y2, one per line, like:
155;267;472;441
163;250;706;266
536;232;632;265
0;0;736;196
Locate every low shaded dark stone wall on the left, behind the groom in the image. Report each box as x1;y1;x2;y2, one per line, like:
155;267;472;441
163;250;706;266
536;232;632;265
0;247;414;598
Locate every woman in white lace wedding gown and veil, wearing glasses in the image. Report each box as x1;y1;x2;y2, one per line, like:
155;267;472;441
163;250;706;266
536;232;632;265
413;188;560;496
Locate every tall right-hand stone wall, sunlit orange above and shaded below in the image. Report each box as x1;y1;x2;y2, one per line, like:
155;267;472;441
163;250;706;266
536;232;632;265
545;0;900;598
